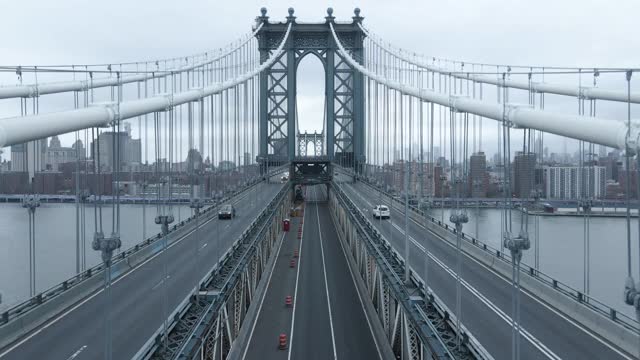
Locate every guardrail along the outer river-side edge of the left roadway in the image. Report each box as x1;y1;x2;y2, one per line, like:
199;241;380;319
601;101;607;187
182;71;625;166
0;168;285;334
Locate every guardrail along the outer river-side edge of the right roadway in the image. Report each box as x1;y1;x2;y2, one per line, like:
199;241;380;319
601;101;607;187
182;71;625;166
341;169;640;332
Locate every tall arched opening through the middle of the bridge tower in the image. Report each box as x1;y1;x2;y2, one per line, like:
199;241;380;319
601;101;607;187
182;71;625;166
296;53;326;155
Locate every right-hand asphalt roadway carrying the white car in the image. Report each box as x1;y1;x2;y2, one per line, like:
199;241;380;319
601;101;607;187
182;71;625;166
340;183;633;359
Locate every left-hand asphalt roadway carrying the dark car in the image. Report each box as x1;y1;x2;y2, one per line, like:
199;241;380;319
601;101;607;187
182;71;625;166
0;183;283;360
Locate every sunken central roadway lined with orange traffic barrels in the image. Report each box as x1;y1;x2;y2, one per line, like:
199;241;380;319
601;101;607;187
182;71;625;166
242;186;381;360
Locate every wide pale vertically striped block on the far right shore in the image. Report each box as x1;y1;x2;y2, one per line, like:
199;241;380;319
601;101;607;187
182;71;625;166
544;166;606;199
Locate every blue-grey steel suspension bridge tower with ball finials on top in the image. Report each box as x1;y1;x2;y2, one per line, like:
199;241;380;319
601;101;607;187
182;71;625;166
256;8;366;184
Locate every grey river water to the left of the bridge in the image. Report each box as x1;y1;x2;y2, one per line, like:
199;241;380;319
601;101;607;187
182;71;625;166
0;203;191;311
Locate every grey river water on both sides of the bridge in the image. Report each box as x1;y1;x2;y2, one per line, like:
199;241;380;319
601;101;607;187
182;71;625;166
0;203;638;317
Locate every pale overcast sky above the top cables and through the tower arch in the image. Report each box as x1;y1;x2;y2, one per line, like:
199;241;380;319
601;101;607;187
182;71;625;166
0;0;640;162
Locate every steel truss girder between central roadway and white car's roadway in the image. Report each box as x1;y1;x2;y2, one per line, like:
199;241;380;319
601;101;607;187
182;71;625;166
330;183;479;359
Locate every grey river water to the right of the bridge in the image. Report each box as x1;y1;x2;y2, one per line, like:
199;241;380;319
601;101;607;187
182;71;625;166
424;209;639;318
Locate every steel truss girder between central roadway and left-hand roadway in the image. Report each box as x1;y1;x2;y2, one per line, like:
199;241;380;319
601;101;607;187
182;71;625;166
144;186;290;360
